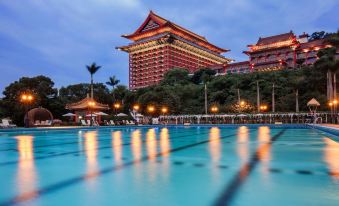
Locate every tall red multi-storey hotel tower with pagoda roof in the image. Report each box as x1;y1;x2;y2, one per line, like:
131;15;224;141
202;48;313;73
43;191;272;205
118;11;230;89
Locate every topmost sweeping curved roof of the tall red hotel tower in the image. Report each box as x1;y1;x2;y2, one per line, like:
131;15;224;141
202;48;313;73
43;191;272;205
122;11;229;54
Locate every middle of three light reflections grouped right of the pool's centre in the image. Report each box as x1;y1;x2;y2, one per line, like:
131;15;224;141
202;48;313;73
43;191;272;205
237;126;249;162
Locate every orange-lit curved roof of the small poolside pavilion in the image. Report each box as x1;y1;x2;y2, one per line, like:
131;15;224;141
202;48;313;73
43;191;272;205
66;97;109;110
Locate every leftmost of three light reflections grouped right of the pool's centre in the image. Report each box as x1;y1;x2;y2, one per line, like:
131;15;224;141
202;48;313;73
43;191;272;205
209;127;221;162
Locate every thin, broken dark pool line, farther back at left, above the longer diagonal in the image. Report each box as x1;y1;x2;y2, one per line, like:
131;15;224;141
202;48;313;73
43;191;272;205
0;131;215;167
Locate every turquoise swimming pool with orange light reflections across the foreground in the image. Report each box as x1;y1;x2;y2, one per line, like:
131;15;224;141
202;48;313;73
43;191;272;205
0;125;339;206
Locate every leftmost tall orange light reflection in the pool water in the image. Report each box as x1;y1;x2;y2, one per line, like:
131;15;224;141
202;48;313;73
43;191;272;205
15;135;37;196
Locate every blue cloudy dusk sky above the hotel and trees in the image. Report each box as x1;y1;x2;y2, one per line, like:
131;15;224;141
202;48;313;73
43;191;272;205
0;0;339;93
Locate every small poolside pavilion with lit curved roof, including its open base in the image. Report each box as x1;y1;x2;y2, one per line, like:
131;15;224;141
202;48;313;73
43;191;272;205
66;96;109;123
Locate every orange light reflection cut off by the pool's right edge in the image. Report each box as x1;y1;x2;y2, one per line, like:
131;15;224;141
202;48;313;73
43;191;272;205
324;138;339;180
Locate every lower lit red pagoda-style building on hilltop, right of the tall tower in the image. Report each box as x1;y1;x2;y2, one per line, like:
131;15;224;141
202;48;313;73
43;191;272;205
215;31;330;75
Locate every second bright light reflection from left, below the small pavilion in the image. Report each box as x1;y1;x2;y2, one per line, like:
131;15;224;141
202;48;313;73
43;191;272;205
84;131;98;179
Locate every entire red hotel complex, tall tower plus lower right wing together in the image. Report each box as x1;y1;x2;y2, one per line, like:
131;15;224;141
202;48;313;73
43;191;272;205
117;11;339;90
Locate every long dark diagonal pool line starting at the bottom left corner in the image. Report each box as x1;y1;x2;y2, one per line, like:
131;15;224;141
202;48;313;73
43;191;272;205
0;130;250;206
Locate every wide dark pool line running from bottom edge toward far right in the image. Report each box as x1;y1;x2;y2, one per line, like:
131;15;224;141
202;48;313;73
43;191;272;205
214;129;286;206
